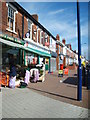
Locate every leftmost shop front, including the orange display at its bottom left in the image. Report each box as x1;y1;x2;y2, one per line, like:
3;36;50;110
0;34;23;86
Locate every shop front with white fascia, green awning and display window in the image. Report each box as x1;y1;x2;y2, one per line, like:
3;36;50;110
24;40;51;71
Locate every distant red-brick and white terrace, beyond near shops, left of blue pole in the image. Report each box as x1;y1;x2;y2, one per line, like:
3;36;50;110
56;35;78;70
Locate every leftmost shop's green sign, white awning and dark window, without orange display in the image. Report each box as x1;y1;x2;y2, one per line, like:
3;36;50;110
0;34;24;67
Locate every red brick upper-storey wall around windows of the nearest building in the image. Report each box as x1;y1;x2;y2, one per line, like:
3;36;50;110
0;2;50;47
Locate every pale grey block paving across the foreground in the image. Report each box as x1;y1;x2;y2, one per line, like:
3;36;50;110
0;88;88;118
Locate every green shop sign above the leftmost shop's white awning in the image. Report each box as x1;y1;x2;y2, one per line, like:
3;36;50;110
0;34;24;45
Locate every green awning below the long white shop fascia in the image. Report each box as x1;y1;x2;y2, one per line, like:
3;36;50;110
23;46;51;57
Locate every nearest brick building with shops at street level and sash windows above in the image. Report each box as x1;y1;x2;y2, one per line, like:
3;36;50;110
0;2;57;71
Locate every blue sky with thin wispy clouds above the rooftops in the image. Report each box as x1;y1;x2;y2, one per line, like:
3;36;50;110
19;2;88;58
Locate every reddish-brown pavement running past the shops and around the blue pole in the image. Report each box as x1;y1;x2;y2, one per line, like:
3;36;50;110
28;70;90;109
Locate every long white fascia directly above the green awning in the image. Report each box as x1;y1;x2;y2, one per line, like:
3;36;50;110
24;38;50;54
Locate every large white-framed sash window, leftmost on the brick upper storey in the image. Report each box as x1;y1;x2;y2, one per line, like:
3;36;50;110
8;6;15;30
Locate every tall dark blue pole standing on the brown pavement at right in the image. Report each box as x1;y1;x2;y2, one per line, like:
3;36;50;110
77;0;82;101
